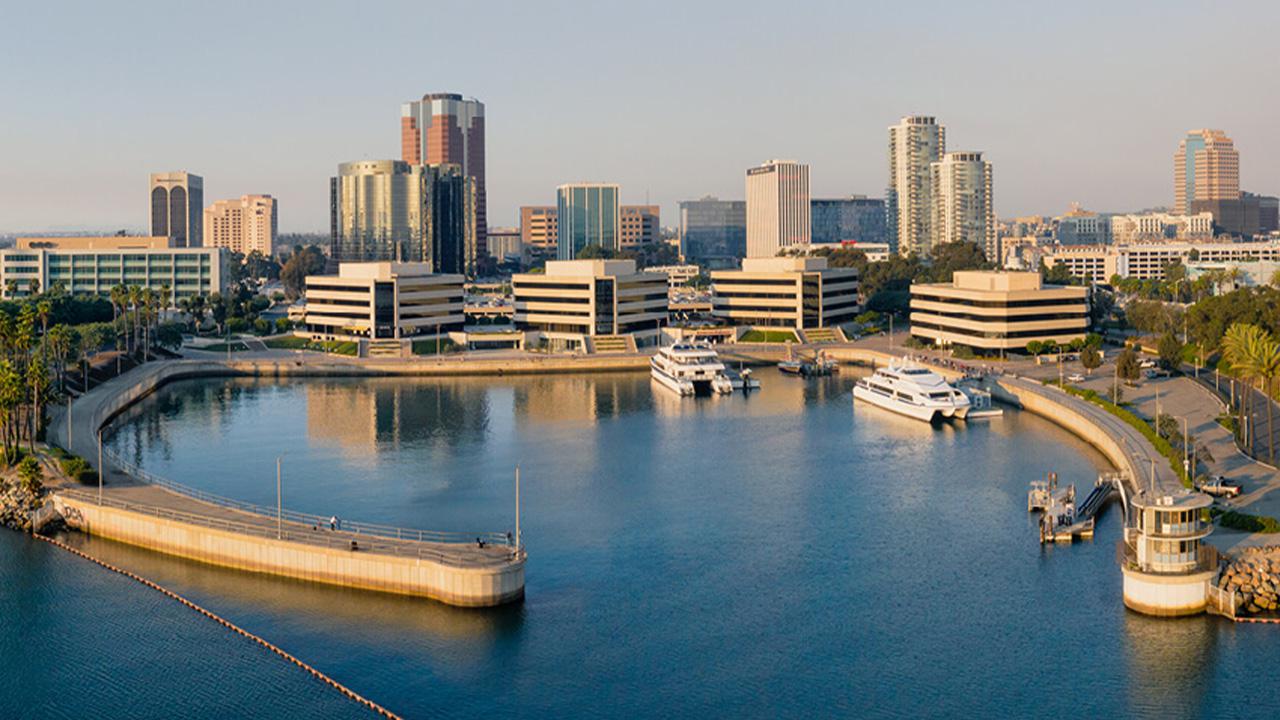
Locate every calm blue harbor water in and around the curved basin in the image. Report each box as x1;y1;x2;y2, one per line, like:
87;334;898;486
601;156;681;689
0;370;1280;717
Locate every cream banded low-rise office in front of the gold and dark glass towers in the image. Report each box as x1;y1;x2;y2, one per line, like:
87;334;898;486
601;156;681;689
302;263;465;341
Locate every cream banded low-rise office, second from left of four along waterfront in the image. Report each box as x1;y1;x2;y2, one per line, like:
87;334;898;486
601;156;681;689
511;260;667;351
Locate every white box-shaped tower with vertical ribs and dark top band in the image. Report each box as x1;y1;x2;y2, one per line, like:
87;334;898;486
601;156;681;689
746;160;810;258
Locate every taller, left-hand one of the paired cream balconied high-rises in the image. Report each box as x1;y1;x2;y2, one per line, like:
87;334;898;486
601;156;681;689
884;115;947;255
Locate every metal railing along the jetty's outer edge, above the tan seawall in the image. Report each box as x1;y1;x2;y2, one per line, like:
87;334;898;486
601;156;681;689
58;488;524;568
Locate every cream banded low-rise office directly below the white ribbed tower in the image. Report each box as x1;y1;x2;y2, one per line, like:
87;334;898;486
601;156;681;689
712;258;859;329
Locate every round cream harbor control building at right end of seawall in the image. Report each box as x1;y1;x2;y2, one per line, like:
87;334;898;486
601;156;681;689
1120;491;1217;618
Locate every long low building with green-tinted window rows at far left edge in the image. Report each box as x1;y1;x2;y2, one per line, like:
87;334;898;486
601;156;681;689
0;236;230;302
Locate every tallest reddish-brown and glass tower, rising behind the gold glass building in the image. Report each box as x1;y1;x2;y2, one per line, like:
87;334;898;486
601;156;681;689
401;92;489;252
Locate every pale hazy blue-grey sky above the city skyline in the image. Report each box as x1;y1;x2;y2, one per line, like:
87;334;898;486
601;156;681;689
0;0;1280;232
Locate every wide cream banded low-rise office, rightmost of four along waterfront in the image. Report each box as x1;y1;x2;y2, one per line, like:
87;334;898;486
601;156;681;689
911;270;1089;351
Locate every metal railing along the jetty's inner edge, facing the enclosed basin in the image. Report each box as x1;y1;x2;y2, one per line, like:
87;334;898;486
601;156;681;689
102;450;513;546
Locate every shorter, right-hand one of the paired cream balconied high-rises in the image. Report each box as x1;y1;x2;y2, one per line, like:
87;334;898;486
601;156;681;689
929;151;1001;263
